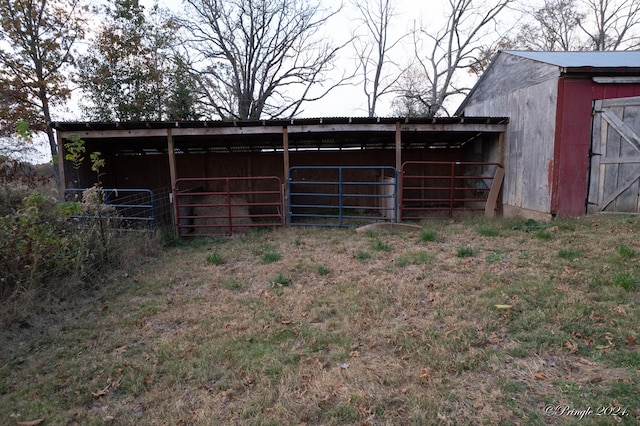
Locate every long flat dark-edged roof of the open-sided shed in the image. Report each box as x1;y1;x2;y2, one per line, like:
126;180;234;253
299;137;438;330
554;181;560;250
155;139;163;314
52;117;509;154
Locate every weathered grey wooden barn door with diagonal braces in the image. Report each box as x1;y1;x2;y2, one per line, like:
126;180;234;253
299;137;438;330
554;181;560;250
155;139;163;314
587;97;640;213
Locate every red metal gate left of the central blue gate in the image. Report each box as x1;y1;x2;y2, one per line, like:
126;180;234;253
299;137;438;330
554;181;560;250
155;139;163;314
173;176;284;236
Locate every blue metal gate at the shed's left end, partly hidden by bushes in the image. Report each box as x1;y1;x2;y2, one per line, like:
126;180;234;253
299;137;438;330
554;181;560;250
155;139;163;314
65;188;158;231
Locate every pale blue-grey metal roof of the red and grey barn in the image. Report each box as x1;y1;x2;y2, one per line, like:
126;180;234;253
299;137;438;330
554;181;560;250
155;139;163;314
504;50;640;68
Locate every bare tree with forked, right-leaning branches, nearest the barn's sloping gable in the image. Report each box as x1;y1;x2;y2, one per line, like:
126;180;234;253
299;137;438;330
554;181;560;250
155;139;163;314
400;0;515;117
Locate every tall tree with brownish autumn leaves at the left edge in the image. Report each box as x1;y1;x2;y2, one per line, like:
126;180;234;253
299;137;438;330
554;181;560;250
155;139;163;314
0;0;86;180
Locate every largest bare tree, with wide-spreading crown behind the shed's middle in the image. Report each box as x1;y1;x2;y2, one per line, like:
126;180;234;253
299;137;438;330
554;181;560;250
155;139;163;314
183;0;344;119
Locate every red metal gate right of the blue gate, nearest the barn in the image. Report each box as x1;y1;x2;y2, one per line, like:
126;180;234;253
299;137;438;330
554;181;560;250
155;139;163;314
399;161;502;220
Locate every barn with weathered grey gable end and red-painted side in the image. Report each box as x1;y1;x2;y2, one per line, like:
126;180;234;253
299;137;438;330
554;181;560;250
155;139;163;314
457;51;640;218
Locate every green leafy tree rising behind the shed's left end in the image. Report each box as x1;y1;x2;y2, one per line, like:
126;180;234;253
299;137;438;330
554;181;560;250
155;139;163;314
79;0;198;121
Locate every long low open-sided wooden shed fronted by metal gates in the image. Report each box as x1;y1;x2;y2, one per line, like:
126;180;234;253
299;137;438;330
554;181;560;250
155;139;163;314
53;117;508;230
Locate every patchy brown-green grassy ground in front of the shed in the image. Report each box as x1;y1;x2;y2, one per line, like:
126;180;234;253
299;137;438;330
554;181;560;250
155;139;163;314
0;216;640;425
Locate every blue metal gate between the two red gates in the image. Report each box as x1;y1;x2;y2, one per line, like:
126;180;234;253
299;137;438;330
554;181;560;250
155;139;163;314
288;166;398;226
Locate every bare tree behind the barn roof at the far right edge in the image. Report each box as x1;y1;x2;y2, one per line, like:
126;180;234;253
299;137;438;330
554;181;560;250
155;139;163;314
579;0;640;50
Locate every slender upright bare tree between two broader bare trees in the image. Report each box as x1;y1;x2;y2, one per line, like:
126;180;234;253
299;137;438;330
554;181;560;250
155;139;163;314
353;0;407;117
